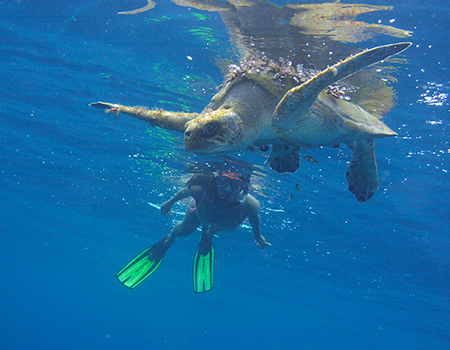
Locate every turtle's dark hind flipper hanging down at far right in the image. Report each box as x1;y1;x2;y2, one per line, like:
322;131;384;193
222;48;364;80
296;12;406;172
345;139;379;203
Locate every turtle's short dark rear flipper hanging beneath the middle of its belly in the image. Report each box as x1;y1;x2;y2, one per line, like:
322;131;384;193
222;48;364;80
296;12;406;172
267;144;300;173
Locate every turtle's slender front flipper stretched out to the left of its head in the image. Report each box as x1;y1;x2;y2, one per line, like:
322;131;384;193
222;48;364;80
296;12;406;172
89;102;198;132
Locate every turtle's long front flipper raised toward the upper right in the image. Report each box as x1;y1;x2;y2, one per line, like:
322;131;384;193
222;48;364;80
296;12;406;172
273;43;411;130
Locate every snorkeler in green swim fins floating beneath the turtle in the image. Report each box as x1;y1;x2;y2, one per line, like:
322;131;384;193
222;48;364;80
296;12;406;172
116;171;270;293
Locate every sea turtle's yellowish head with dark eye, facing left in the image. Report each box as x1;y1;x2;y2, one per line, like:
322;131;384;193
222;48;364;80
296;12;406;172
184;108;249;154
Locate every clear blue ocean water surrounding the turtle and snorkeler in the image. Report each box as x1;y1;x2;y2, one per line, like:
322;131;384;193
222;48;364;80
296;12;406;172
0;0;450;350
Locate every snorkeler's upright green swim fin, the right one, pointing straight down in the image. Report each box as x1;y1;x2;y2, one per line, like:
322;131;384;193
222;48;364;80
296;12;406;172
193;235;214;293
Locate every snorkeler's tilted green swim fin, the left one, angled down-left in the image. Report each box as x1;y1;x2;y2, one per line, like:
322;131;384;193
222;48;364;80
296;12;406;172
116;245;164;289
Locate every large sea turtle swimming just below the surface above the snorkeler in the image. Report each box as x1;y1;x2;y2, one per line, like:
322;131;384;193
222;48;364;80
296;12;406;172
90;0;411;202
